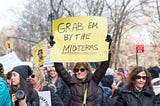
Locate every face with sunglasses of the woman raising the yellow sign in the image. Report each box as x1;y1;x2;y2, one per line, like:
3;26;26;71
74;66;88;81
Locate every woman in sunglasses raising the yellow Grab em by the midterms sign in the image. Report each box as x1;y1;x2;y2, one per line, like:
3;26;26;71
54;53;111;106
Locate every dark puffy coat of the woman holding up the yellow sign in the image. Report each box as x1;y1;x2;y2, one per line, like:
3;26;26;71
55;61;109;106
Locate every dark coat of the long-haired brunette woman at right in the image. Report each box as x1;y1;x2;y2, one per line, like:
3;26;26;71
113;87;155;106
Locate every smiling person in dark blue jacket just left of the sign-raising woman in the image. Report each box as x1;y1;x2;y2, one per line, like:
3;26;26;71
47;66;71;106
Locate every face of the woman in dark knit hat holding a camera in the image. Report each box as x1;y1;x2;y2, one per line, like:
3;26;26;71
11;71;20;85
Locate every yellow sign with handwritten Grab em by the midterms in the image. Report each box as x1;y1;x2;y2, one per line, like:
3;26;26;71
51;16;109;62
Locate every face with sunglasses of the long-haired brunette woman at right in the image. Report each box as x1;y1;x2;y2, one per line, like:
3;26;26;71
135;71;146;91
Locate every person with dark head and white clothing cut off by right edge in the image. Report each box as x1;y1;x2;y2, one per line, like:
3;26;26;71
147;66;160;106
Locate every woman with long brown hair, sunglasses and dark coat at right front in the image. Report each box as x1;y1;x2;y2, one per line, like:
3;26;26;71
113;66;155;106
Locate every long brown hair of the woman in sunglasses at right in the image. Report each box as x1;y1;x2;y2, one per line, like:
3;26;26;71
125;66;153;91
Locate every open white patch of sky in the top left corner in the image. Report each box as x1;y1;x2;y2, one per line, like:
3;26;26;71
0;0;26;30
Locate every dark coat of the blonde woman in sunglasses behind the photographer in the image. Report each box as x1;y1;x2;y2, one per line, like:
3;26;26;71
42;86;64;106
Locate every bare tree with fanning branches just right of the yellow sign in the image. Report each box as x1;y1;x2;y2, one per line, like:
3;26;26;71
105;0;144;69
